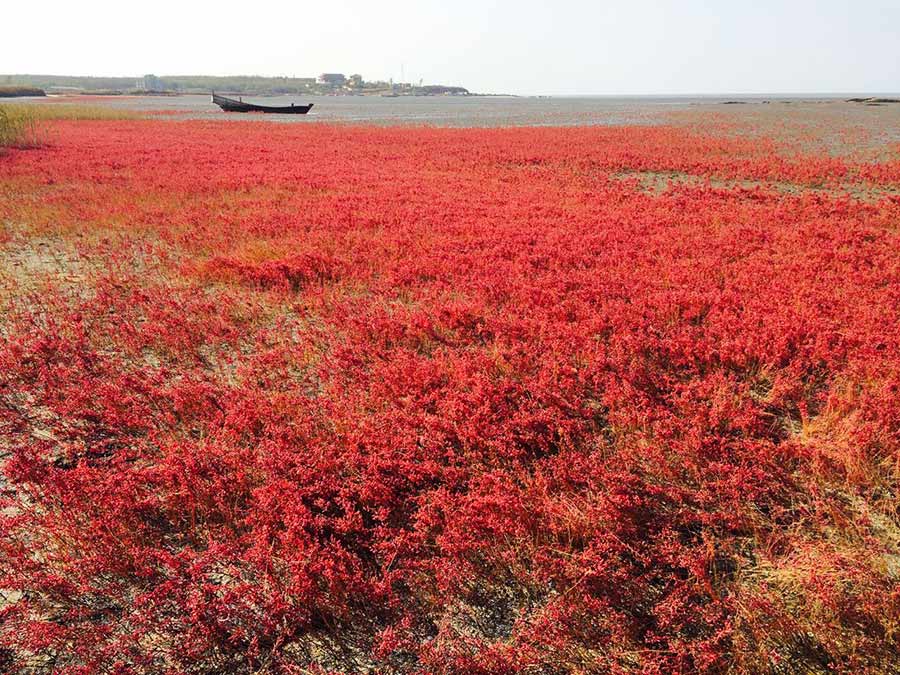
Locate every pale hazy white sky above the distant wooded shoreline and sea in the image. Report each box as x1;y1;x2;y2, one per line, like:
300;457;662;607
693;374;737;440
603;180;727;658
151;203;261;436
7;0;900;94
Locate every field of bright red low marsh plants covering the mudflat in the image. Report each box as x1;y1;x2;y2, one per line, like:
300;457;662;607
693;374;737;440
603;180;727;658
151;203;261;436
0;113;900;675
